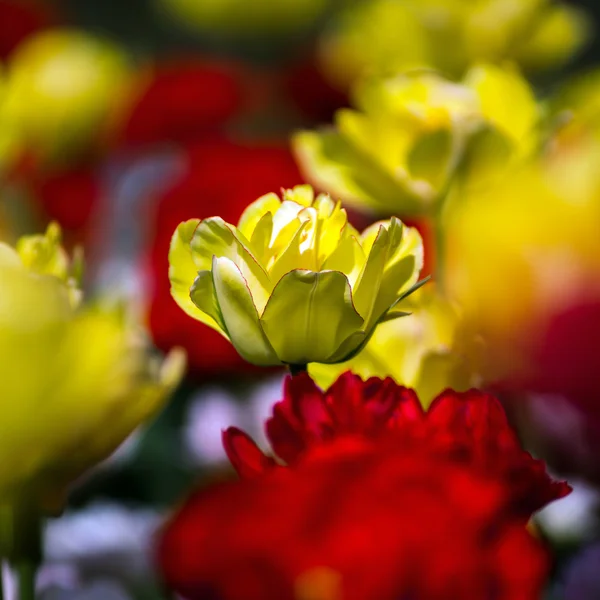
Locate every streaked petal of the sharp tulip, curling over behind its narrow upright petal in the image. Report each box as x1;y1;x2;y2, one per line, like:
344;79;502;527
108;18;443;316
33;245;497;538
191;217;272;311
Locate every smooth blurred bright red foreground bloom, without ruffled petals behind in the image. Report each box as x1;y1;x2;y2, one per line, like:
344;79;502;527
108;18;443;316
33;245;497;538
157;438;548;600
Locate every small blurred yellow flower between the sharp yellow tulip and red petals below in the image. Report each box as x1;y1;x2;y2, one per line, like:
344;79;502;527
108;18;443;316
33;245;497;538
309;286;476;406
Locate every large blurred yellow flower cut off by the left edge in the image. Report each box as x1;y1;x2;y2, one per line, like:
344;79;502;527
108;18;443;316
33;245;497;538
0;225;184;512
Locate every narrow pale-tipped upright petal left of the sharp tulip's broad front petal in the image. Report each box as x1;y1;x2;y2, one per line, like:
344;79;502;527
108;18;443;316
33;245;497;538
212;256;281;366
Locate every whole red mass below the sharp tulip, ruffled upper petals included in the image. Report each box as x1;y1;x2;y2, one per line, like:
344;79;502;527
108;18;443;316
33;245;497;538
157;373;569;600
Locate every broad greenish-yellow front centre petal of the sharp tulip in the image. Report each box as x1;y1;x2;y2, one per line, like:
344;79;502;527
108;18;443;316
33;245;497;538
261;270;363;364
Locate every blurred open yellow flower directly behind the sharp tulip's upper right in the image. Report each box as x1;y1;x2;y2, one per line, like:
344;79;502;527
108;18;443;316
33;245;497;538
294;65;540;215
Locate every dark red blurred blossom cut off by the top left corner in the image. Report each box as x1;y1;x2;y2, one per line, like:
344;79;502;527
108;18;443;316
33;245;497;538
0;0;56;60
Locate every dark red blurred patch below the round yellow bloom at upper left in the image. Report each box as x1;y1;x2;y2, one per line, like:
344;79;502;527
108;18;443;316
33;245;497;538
29;165;100;231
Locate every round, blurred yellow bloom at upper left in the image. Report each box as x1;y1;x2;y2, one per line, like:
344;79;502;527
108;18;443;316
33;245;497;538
0;29;131;164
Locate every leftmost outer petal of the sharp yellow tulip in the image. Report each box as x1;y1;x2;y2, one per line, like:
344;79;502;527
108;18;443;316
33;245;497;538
169;219;221;332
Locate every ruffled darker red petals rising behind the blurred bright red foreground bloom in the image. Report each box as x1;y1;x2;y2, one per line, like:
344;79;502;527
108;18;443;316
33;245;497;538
223;372;570;518
